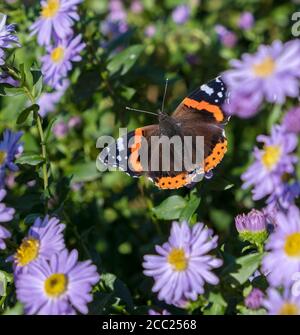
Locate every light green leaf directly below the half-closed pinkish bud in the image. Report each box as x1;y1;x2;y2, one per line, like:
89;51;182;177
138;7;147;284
231;252;263;285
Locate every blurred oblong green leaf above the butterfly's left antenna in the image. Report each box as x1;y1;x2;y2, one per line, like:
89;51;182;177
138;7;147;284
107;45;144;76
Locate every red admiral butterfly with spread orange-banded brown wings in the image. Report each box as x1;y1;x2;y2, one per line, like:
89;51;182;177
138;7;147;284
100;77;228;189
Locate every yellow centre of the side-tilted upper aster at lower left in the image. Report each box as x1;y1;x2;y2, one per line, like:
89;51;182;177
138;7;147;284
15;237;40;266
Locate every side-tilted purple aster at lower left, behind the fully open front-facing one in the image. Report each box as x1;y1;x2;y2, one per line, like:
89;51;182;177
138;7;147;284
10;216;65;276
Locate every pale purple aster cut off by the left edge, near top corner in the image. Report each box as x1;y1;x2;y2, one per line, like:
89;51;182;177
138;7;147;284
0;14;20;65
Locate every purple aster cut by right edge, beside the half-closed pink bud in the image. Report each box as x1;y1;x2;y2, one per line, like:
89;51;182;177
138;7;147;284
262;206;300;286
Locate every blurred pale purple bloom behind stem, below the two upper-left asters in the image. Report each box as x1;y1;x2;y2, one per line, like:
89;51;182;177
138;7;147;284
37;79;70;117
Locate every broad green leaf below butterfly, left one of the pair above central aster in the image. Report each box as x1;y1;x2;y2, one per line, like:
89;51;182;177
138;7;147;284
152;195;186;220
